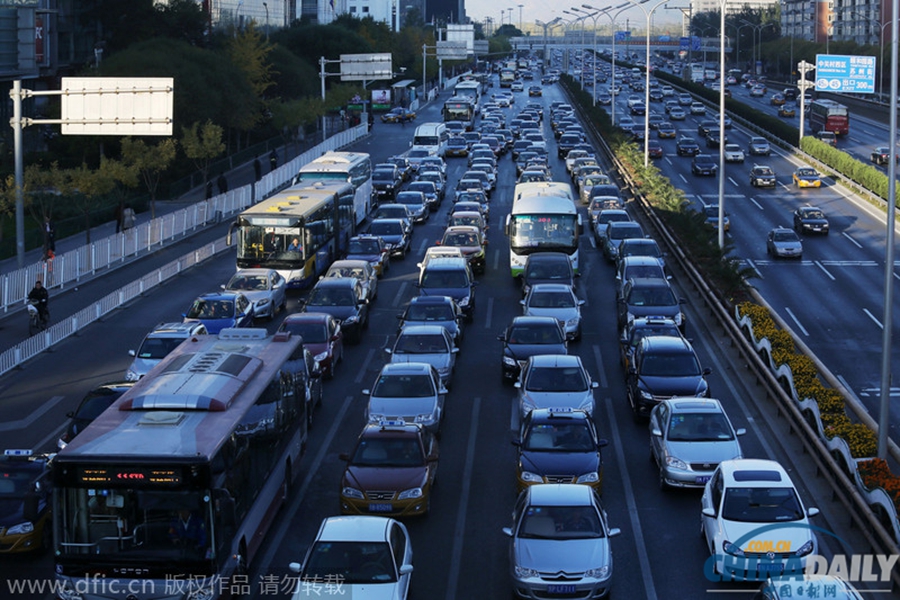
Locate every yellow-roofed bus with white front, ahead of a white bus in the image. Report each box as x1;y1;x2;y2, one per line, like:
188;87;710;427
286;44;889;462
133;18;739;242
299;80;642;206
226;180;356;289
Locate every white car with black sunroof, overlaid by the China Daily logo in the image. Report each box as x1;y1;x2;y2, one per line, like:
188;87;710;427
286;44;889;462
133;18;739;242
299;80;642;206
700;458;819;581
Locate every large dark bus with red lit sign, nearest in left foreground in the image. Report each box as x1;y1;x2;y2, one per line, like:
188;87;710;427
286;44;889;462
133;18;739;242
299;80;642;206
52;328;309;600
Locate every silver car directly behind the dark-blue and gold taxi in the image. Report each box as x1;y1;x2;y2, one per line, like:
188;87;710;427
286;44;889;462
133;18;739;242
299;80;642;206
514;354;598;418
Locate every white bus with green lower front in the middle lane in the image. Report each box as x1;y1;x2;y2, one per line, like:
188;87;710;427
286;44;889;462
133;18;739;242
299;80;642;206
505;182;583;277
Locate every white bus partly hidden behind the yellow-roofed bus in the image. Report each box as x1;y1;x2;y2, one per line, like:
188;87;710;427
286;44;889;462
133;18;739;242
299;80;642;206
293;152;372;227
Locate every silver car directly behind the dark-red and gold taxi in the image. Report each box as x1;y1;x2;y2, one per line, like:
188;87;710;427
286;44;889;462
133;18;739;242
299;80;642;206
363;362;447;433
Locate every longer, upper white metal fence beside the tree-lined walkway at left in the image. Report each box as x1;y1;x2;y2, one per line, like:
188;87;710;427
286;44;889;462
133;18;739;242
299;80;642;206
0;124;368;318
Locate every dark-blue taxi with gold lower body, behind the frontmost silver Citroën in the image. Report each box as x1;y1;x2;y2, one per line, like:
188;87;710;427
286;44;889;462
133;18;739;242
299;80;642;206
513;408;609;494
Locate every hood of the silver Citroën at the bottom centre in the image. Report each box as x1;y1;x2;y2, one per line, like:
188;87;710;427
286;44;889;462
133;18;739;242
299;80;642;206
515;538;611;573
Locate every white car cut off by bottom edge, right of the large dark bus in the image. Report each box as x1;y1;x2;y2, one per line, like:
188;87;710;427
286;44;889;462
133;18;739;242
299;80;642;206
289;516;413;600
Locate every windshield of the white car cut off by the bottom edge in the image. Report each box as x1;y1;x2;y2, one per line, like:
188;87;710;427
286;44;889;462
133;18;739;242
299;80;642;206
300;542;397;585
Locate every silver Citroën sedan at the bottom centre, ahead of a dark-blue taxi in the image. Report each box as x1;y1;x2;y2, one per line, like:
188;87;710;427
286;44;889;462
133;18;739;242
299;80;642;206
503;483;621;598
